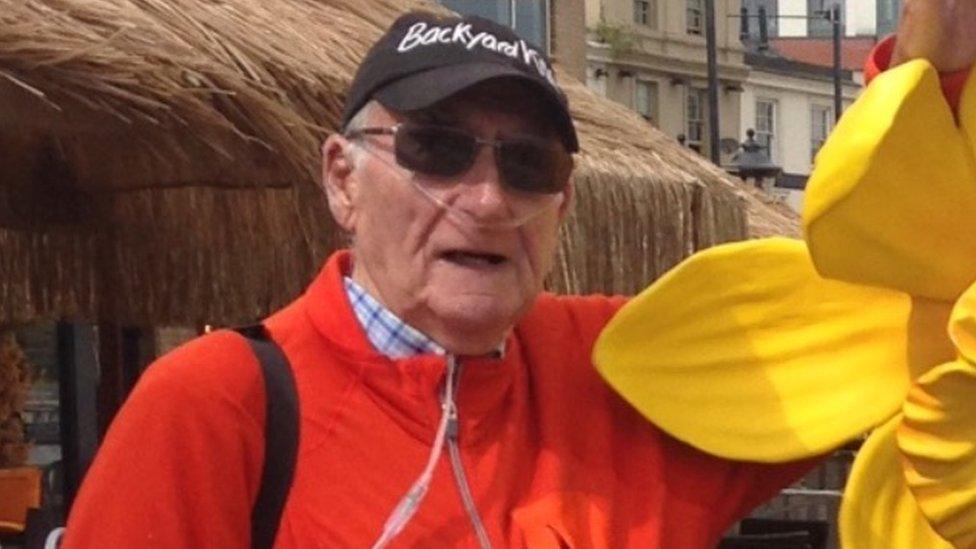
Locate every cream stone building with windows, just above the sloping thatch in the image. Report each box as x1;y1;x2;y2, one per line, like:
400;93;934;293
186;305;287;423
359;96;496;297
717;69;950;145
586;0;748;162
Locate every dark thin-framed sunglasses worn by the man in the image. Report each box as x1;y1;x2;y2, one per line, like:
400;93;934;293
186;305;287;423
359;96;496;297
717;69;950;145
346;122;573;194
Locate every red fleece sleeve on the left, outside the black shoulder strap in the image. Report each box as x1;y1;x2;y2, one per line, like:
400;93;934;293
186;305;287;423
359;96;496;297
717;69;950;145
64;332;264;549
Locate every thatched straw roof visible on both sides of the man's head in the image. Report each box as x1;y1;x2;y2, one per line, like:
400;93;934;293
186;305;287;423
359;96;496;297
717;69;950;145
0;0;796;324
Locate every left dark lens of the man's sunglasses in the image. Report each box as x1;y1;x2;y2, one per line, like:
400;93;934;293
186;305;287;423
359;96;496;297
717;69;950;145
396;124;477;177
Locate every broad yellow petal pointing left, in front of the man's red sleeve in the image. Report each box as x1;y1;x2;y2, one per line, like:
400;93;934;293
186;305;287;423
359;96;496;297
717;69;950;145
594;238;916;461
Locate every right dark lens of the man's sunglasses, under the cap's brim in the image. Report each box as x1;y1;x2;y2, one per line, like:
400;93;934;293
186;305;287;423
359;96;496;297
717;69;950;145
498;139;573;194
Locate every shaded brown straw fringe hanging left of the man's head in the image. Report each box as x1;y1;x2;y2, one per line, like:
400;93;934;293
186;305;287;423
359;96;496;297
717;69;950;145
0;189;342;325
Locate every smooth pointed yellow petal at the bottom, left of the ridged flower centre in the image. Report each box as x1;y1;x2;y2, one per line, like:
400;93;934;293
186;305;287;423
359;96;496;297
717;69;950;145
840;415;952;549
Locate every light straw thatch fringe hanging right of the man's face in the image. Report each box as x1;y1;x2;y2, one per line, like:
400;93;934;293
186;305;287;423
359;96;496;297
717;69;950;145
549;156;746;295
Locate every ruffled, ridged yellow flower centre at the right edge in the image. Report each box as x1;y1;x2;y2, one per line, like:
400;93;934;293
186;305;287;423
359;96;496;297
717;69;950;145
898;280;976;547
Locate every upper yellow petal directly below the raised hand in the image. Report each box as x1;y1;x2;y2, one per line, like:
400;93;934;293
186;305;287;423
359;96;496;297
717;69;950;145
804;61;976;301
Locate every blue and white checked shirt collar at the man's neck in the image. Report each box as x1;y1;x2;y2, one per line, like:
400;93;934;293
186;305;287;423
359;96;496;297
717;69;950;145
342;276;446;358
